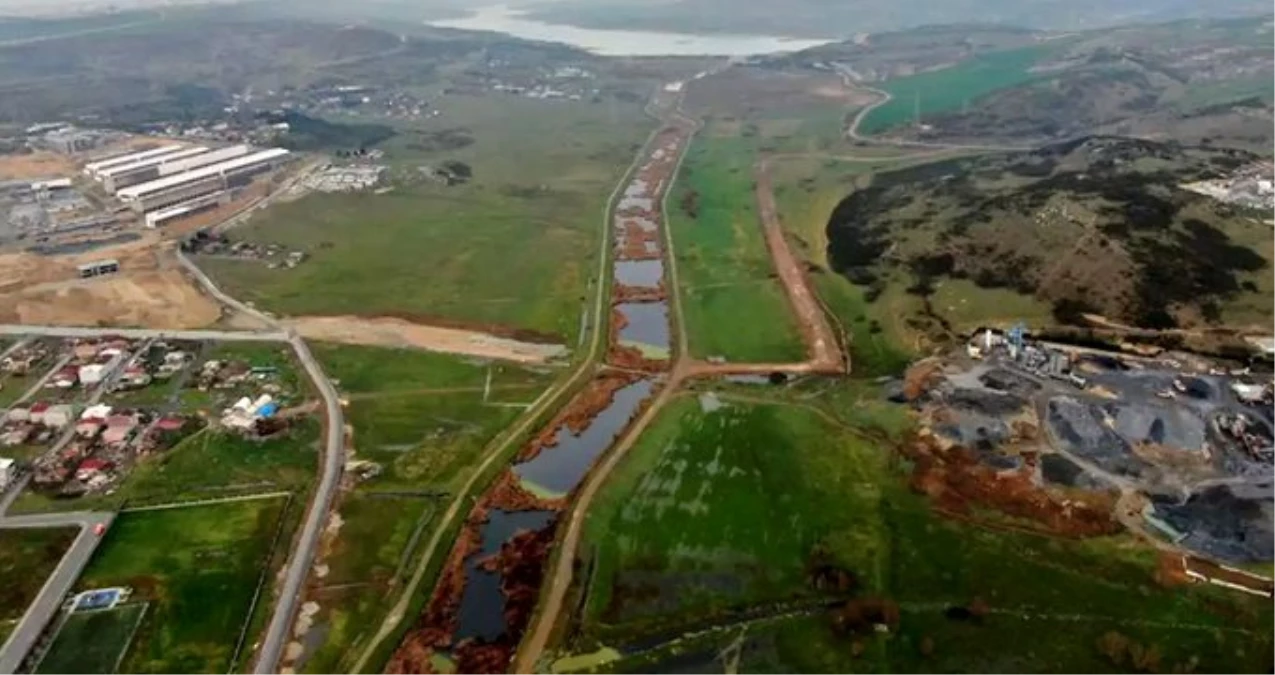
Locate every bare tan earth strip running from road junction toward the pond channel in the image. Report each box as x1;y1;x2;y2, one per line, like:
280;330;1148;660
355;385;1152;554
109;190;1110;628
291;316;566;364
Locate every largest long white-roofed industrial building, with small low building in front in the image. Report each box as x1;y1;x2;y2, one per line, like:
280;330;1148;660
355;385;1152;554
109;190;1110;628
115;148;291;213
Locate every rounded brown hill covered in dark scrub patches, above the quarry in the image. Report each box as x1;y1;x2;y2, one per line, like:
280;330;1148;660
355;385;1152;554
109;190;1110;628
827;137;1270;328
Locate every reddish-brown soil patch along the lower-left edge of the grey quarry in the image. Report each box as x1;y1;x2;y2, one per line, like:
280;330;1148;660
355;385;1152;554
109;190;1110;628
903;433;1122;538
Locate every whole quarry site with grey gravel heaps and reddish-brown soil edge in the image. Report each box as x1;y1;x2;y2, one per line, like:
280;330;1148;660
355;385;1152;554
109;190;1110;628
895;327;1275;595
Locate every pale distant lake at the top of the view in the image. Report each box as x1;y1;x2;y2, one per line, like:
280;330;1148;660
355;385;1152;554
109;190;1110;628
426;6;831;56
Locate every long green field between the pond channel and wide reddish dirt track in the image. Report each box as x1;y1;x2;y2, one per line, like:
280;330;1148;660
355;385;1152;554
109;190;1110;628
667;129;806;362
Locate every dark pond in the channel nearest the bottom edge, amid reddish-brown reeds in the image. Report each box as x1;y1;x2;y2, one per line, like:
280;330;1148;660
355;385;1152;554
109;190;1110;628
455;509;555;642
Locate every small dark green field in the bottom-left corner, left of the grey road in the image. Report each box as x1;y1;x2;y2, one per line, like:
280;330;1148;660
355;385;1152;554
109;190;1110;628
0;527;78;643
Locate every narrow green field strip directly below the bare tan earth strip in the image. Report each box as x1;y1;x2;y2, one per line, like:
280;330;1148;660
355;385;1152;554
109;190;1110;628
310;343;556;398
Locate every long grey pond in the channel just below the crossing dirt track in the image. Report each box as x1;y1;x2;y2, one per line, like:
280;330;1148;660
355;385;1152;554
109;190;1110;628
514;380;654;494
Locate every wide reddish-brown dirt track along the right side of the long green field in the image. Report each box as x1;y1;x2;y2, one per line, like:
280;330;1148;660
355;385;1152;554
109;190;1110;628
756;159;849;375
